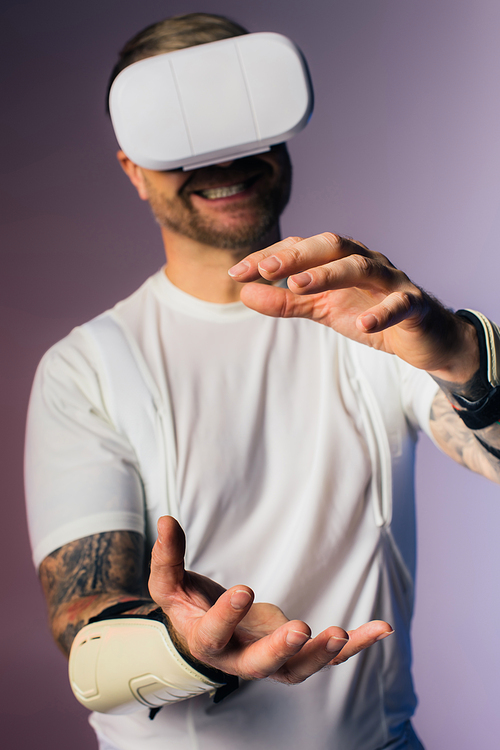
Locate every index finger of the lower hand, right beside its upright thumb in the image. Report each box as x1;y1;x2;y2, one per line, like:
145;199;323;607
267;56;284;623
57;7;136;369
189;586;254;661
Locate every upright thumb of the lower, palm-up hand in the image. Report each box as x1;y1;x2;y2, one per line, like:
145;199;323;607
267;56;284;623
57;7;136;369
149;516;186;607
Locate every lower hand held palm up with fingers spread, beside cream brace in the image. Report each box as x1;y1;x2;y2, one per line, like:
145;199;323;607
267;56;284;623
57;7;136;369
149;516;392;683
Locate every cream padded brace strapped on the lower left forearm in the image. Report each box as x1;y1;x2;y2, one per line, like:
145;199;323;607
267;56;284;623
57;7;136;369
69;617;222;714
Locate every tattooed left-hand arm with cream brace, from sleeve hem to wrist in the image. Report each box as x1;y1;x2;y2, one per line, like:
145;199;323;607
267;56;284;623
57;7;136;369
40;531;237;712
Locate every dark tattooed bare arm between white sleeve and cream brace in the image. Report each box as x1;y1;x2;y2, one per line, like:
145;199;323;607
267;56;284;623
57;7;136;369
40;531;152;654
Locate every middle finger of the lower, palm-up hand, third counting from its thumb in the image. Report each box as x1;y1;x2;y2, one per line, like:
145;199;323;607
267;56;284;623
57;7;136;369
237;620;311;680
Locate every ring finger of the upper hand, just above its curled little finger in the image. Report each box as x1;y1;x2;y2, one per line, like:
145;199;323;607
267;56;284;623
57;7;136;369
288;253;411;294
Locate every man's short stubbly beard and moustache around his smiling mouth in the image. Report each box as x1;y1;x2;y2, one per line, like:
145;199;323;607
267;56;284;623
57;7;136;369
146;146;291;250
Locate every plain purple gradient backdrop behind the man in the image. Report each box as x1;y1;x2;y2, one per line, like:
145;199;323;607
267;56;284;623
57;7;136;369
0;0;500;750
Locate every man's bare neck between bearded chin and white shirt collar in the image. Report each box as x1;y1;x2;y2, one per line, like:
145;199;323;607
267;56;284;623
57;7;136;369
161;225;280;304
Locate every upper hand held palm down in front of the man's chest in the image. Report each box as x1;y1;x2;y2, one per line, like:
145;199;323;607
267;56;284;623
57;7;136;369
229;232;479;382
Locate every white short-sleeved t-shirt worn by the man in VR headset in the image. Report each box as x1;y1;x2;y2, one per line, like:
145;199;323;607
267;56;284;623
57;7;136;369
26;271;436;750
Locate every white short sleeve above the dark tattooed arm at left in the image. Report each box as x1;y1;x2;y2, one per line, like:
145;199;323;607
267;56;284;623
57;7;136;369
25;328;145;567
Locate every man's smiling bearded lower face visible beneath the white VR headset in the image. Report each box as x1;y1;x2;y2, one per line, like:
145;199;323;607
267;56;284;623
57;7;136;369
142;144;291;250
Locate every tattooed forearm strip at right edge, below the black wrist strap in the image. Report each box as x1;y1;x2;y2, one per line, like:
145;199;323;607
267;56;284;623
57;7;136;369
430;391;500;483
